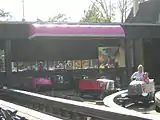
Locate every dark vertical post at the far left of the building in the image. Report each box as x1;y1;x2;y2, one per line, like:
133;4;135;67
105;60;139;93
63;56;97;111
5;40;12;86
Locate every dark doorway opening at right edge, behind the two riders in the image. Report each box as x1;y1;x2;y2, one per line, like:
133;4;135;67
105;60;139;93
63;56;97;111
143;39;160;84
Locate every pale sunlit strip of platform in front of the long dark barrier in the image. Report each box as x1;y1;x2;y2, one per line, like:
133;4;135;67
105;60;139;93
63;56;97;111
0;100;62;120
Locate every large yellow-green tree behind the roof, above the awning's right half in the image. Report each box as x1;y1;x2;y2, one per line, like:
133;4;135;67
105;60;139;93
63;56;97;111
80;0;115;23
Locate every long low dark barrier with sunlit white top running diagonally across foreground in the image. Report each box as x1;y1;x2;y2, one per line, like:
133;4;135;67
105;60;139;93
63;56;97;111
0;89;156;120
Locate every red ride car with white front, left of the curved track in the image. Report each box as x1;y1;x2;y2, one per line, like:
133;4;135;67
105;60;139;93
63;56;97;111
78;76;115;99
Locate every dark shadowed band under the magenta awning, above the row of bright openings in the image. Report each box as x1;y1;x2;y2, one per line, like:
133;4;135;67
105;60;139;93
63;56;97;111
12;37;120;61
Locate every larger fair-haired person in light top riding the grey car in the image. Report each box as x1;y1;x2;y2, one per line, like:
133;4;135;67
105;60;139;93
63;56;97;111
131;65;144;80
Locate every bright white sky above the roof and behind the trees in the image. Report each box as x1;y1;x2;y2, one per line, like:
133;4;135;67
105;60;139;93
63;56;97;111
0;0;129;22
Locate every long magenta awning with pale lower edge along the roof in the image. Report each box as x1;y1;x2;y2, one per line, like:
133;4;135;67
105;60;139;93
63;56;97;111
29;24;125;39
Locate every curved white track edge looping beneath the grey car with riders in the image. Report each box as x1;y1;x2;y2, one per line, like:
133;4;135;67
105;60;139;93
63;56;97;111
103;90;160;116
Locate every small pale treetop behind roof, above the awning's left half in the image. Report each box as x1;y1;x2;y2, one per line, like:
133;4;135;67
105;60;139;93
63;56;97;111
48;13;70;22
